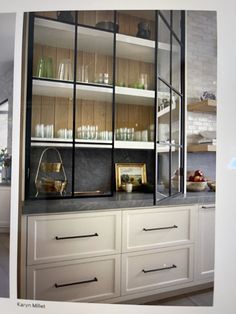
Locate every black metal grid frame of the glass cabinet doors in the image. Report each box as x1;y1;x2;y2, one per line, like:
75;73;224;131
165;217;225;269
25;10;185;205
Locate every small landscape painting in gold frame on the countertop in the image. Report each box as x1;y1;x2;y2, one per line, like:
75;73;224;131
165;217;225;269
115;163;147;191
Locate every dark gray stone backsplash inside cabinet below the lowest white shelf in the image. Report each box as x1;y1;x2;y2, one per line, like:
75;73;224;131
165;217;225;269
30;147;154;196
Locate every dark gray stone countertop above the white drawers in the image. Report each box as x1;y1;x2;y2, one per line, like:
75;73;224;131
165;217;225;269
23;192;215;215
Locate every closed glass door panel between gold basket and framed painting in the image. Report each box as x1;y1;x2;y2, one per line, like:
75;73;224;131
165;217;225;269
74;11;114;196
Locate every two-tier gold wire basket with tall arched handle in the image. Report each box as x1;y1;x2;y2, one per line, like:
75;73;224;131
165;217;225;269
34;147;67;197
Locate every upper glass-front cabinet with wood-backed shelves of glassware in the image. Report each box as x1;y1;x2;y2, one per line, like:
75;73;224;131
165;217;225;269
25;11;185;203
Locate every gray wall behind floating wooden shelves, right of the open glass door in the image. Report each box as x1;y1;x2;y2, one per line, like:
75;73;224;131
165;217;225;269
186;11;217;179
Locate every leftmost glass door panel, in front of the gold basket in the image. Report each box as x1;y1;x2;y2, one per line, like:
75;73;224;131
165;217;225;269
26;16;75;198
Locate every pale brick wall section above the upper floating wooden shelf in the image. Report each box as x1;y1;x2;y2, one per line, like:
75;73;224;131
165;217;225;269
187;11;217;102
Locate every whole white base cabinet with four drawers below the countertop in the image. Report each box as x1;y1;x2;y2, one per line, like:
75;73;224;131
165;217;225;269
21;205;214;303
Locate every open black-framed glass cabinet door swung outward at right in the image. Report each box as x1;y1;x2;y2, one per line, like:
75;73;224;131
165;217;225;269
156;11;184;201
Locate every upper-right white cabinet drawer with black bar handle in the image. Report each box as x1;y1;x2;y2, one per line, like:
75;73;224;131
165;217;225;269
122;206;196;252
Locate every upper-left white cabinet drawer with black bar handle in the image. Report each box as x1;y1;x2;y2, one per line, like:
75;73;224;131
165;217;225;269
27;211;121;265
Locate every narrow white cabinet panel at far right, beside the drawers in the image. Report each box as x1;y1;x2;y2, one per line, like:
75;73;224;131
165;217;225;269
196;205;215;280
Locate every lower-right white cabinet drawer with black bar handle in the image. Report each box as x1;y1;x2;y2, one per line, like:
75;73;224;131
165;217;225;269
122;247;193;295
